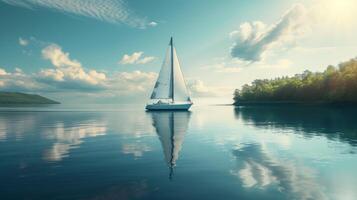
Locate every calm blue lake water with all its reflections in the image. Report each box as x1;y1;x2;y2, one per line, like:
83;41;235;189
0;105;357;200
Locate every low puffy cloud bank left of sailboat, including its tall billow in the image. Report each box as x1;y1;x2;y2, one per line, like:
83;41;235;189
0;44;157;101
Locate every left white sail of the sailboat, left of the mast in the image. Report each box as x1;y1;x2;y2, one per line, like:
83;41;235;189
151;48;172;99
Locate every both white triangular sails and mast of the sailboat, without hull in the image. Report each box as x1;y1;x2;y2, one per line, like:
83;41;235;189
151;38;191;102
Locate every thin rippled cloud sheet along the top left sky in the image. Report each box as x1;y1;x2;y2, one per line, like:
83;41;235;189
2;0;152;28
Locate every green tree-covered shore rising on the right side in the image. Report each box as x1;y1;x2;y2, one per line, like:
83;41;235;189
233;58;357;105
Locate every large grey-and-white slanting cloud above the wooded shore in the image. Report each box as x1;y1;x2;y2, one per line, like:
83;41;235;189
230;4;307;62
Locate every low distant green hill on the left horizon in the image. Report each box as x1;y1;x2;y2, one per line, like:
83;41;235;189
0;92;59;105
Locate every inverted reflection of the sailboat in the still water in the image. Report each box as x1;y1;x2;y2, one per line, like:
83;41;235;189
151;111;190;180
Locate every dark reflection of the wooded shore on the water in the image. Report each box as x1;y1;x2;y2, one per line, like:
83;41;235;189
235;106;357;146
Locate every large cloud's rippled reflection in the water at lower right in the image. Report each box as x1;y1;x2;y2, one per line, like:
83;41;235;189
231;144;327;200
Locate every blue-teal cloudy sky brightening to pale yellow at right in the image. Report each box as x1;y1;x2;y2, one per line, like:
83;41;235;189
0;0;357;103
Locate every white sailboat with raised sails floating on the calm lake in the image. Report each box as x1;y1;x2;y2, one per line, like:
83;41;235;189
146;37;192;110
